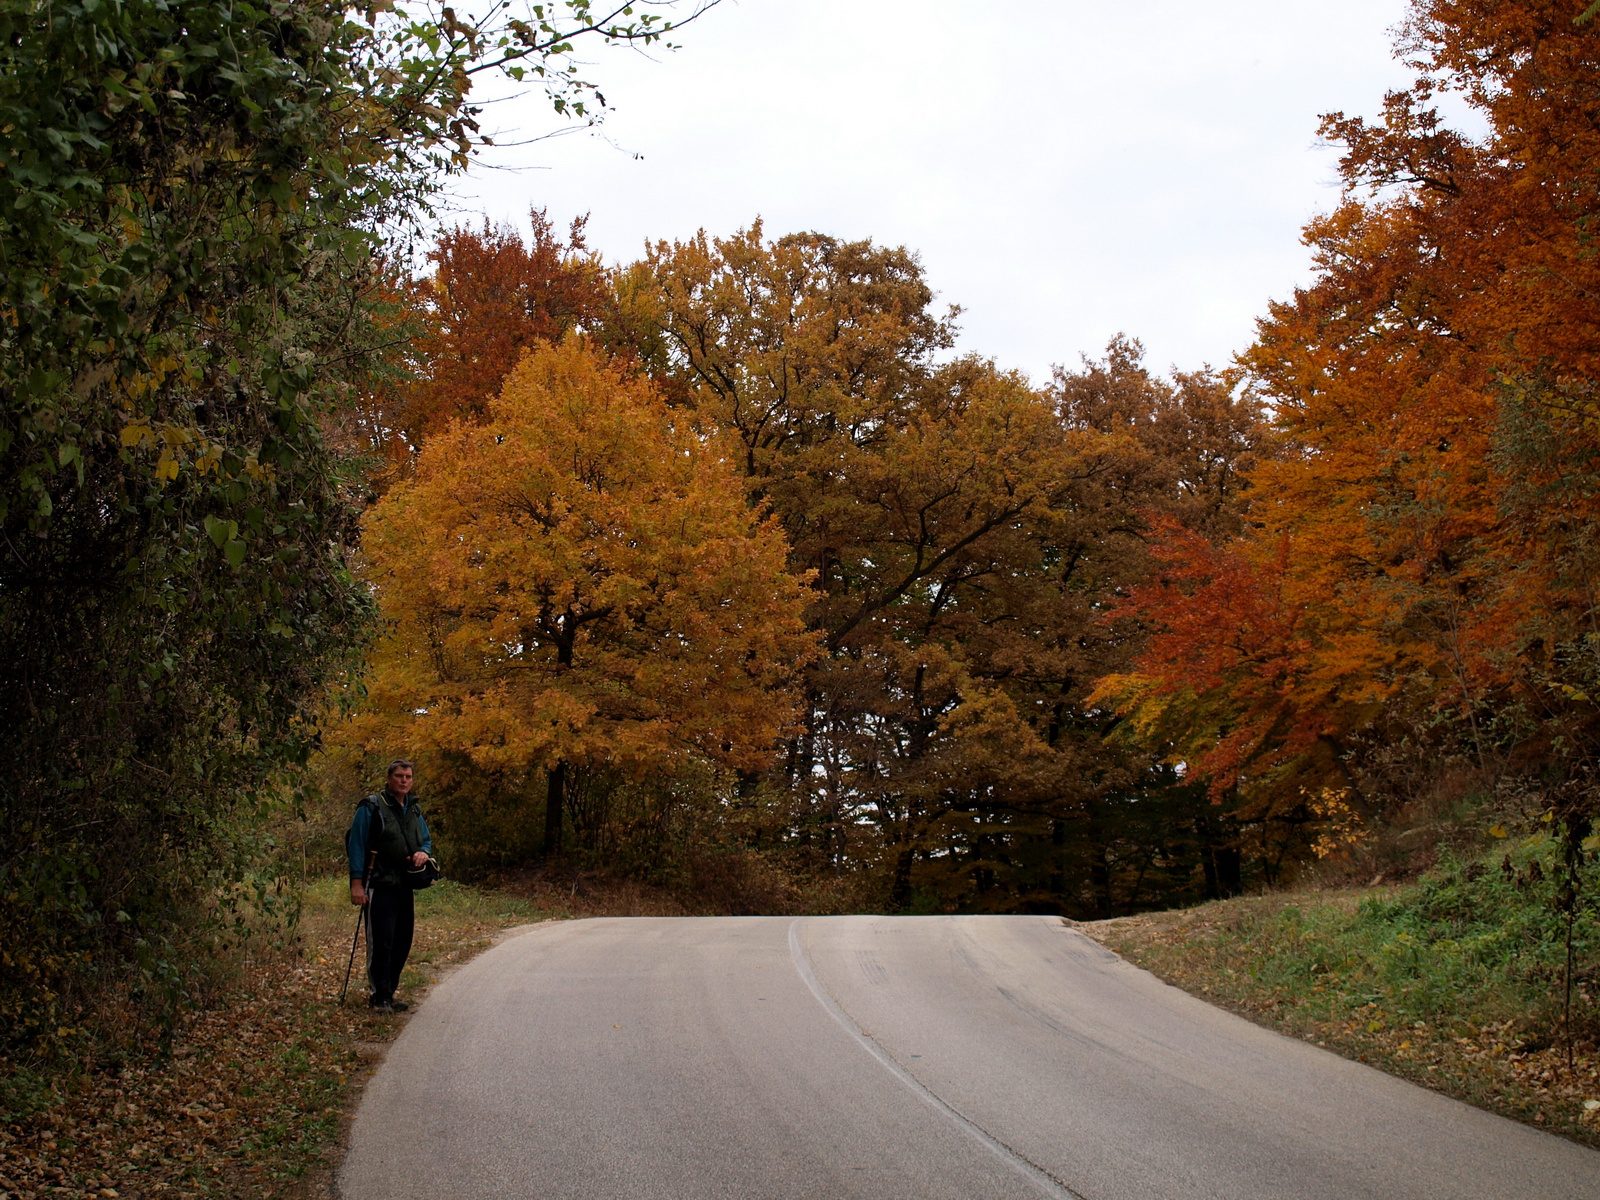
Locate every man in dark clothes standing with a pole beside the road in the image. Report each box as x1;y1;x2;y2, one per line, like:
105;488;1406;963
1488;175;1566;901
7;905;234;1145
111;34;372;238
344;758;434;1013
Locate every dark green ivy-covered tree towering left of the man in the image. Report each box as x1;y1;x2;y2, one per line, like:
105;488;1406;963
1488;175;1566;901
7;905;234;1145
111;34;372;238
0;0;707;1040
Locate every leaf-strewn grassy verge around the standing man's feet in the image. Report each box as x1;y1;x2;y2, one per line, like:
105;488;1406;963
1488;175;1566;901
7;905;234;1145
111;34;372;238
0;878;569;1200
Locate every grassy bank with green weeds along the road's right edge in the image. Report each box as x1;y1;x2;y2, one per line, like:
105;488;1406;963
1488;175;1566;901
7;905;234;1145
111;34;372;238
1077;867;1600;1147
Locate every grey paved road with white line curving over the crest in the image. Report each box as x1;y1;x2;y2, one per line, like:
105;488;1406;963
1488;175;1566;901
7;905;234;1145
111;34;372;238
341;917;1600;1200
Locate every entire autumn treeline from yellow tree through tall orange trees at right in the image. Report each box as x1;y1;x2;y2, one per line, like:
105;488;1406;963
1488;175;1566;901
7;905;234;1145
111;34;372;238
318;0;1600;915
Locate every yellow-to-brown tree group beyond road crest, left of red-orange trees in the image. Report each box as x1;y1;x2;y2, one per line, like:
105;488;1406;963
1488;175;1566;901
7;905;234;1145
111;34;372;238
330;213;1273;914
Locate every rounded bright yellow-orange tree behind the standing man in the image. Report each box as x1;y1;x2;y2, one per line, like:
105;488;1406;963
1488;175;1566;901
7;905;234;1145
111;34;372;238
355;338;814;854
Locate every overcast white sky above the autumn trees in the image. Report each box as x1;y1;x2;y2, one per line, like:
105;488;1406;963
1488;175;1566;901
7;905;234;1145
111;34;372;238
456;0;1410;379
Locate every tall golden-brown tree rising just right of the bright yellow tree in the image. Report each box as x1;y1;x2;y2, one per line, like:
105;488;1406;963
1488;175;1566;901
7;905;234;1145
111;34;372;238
619;226;1051;899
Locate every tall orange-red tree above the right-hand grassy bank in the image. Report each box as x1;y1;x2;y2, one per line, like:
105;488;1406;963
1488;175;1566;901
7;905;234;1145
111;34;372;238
1100;0;1600;883
